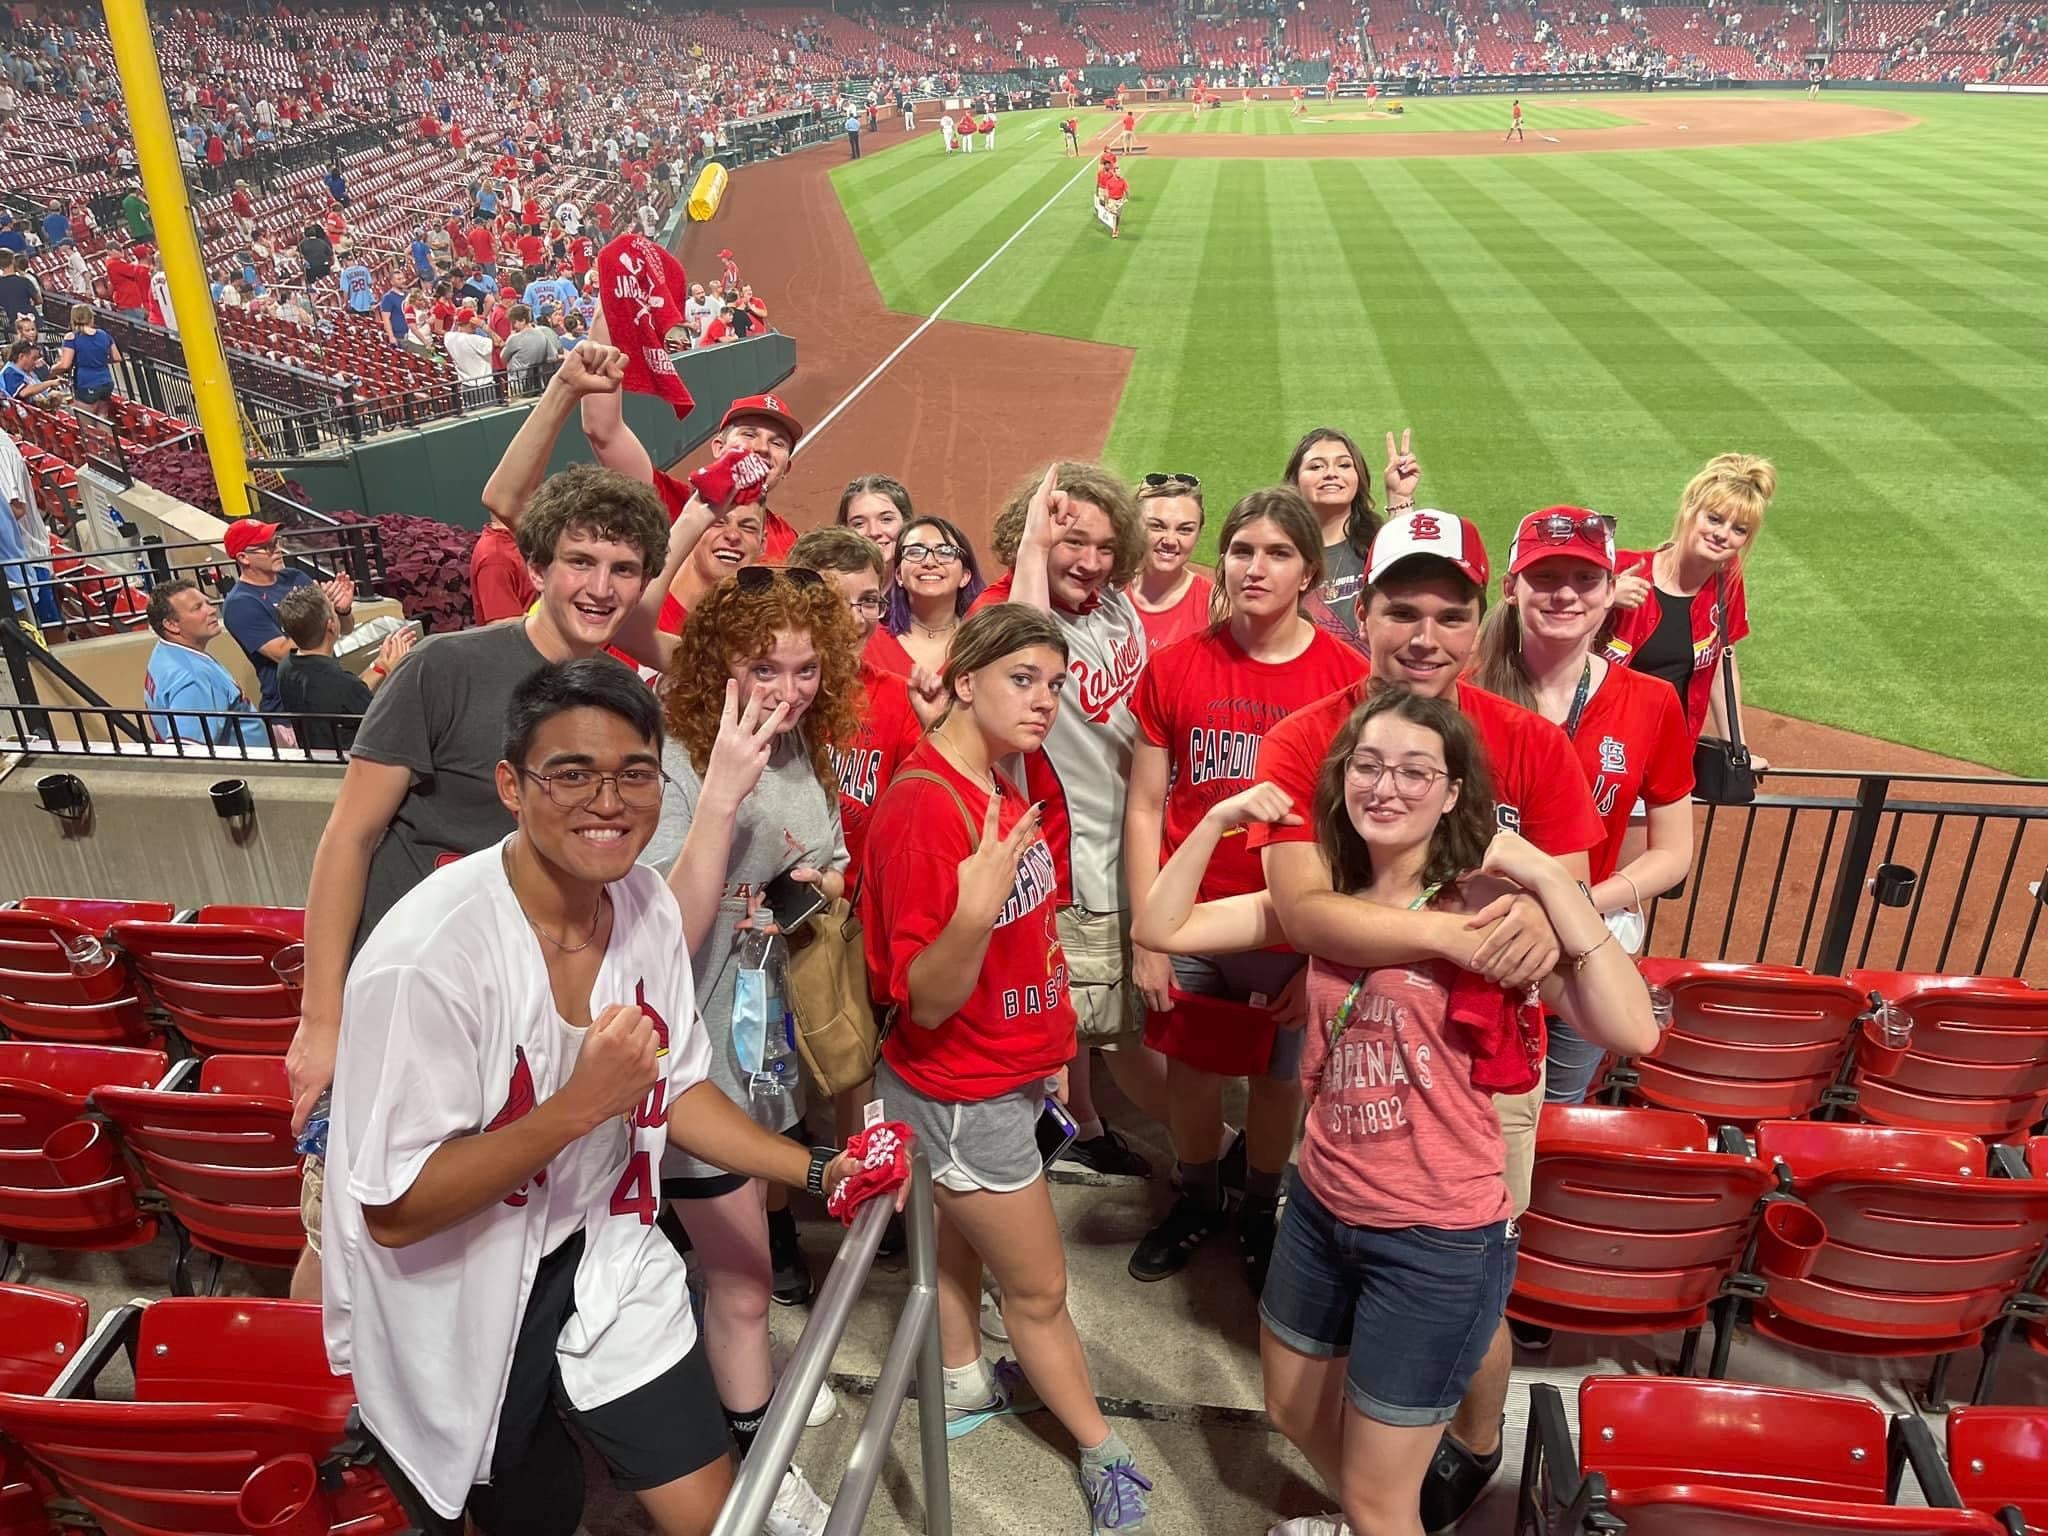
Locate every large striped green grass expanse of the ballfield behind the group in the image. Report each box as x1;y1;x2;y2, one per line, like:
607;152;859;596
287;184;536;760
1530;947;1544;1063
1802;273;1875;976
834;92;2048;774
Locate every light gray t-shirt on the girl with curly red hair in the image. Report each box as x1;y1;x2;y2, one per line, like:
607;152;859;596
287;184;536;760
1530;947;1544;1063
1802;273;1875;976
641;733;848;1178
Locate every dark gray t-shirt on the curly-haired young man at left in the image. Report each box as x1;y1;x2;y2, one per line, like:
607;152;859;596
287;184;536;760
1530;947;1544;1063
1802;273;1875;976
350;618;547;954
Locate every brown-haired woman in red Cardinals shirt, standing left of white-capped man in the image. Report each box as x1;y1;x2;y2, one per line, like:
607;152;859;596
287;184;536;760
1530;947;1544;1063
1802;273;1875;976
1124;485;1366;1294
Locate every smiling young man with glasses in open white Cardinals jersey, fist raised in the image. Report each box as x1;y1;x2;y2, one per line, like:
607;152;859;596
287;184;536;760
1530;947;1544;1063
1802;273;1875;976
324;657;856;1536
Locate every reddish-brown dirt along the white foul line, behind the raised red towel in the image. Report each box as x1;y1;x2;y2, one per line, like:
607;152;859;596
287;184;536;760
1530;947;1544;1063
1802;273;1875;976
682;127;1130;549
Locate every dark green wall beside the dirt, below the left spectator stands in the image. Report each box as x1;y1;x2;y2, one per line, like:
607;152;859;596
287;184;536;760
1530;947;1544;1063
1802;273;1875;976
284;332;797;528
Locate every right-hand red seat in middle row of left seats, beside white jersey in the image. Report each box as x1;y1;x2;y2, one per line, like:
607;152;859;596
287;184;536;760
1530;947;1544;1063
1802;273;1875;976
92;1057;305;1296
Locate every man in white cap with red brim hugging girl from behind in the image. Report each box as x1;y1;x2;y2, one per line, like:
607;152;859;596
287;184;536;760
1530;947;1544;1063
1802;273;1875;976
1247;510;1604;1530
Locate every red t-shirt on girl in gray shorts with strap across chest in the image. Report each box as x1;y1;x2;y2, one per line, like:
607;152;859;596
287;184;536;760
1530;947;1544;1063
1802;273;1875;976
860;741;1075;1104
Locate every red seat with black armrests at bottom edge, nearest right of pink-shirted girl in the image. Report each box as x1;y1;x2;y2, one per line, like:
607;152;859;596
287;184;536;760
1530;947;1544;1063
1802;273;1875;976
1518;1376;2005;1536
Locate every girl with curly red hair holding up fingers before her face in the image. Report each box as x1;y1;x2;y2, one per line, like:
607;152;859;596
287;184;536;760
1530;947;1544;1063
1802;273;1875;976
641;565;860;1530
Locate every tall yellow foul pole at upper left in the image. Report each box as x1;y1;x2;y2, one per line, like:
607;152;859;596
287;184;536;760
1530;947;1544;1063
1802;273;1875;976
104;0;250;518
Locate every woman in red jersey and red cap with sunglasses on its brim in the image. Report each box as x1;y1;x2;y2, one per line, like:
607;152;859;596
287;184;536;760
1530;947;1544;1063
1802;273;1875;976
1473;506;1692;1104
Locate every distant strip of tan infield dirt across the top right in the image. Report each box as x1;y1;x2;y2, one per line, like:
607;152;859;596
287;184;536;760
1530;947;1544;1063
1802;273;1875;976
1139;96;1919;160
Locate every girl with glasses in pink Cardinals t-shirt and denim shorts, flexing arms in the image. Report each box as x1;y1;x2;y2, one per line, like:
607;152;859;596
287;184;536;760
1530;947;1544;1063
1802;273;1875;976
1135;688;1657;1532
